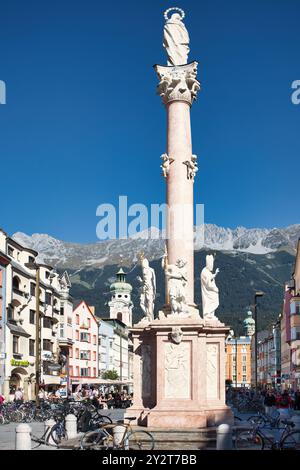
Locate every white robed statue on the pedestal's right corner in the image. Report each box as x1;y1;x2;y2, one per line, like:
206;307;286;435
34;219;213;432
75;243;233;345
201;255;219;320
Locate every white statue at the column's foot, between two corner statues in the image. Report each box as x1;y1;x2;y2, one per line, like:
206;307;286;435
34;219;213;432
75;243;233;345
162;248;188;315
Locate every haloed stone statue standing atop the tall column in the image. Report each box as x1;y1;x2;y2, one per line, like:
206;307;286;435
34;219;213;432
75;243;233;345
163;8;190;66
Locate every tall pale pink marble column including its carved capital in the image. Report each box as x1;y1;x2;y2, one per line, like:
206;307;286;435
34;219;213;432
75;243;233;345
154;62;200;305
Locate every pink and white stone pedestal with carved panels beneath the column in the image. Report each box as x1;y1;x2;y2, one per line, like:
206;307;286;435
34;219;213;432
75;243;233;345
126;314;233;428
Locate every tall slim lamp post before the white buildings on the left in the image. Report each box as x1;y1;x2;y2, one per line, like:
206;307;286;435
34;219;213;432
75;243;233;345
25;262;41;406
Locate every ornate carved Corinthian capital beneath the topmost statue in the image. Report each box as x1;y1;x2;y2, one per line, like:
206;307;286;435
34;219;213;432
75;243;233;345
154;62;200;105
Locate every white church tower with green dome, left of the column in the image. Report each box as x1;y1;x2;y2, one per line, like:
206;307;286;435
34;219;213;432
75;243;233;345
108;268;133;328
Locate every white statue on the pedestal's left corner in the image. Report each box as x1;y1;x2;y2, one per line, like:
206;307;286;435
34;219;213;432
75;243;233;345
138;257;156;321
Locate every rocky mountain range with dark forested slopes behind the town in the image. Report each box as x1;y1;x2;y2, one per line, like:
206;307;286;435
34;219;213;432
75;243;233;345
13;224;300;334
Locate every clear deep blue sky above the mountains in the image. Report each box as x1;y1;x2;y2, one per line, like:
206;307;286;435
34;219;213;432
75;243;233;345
0;0;300;242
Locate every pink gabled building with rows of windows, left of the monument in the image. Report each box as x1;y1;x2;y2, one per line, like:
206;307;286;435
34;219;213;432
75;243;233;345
69;301;99;391
